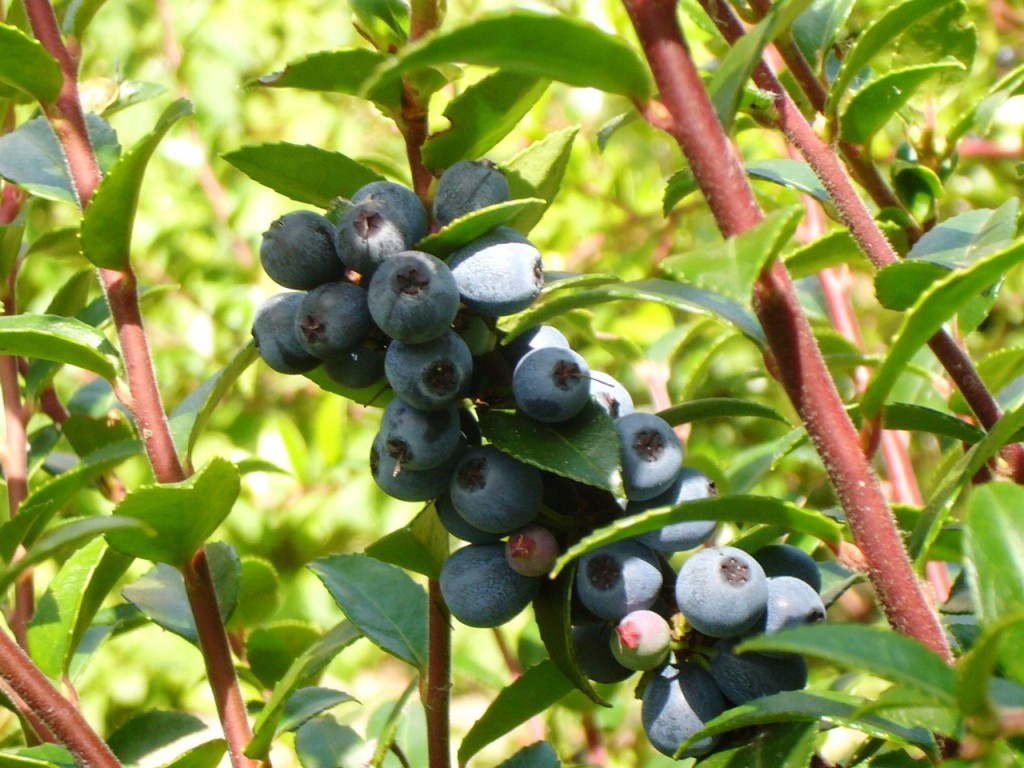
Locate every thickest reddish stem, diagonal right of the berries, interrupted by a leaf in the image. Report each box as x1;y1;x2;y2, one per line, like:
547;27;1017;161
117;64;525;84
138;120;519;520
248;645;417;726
624;0;951;659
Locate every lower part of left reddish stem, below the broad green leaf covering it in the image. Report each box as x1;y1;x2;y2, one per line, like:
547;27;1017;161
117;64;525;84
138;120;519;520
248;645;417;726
181;549;259;768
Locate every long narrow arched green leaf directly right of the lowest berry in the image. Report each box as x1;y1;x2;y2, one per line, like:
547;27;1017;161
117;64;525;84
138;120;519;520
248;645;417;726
682;691;935;753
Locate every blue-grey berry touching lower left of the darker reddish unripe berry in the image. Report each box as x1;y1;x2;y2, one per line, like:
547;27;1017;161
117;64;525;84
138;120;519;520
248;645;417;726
440;544;541;627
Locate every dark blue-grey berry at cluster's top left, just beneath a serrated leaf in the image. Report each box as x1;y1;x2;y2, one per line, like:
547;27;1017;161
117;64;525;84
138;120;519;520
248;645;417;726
259;211;345;291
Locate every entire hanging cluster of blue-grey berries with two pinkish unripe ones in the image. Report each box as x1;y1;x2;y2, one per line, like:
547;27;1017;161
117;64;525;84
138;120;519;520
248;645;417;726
253;161;824;755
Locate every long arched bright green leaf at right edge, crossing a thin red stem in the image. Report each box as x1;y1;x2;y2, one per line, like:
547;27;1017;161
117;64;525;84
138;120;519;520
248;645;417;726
860;243;1024;418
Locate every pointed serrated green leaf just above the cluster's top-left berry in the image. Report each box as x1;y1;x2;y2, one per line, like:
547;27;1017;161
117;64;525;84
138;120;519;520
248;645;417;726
223;141;384;210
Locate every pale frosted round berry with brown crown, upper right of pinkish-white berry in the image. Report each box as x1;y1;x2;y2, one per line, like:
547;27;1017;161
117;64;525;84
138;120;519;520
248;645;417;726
676;547;768;637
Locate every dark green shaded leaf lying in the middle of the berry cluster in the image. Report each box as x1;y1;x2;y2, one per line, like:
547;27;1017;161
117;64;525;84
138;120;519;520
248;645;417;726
479;402;623;494
